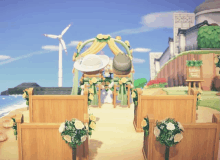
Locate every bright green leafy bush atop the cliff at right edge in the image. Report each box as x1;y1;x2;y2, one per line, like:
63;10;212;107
197;26;220;48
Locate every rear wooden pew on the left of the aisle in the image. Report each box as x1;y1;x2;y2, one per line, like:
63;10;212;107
28;88;88;123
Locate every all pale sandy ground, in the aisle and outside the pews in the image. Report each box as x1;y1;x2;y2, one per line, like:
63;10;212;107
0;89;220;160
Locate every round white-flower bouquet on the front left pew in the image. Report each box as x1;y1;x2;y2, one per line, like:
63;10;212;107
59;118;88;149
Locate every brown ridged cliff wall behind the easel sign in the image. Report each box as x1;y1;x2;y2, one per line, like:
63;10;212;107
157;51;217;91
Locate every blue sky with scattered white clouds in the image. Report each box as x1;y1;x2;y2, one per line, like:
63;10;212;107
0;0;204;92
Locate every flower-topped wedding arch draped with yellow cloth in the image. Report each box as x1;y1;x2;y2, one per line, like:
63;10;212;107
71;34;134;107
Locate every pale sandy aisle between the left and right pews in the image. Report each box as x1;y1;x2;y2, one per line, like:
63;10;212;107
89;104;144;160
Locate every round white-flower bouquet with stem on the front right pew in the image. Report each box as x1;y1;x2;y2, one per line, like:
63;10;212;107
154;118;184;160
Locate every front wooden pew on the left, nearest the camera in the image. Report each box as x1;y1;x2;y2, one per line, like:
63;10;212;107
16;114;89;160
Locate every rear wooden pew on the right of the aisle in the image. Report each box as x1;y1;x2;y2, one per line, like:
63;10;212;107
133;88;197;132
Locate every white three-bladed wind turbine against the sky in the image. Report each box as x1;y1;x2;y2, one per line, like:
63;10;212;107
44;24;71;87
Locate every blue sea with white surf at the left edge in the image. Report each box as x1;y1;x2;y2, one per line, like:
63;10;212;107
0;95;27;118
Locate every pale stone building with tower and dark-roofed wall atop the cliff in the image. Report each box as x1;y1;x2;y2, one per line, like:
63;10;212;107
150;0;220;79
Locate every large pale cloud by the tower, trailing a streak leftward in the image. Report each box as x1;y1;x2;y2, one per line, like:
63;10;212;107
110;11;185;37
